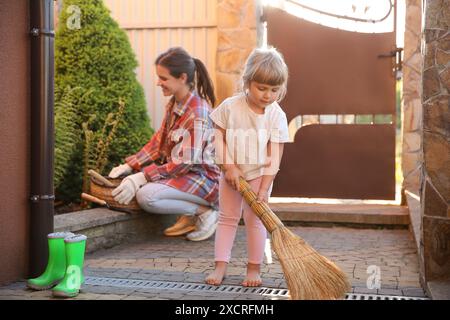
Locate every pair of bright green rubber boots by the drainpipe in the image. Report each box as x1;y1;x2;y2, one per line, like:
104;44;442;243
27;232;87;298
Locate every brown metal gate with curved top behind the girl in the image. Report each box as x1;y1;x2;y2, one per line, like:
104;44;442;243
264;1;399;199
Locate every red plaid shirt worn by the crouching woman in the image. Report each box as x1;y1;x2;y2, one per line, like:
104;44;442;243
126;92;220;207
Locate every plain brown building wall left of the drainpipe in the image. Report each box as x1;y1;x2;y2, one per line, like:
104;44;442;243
0;0;30;284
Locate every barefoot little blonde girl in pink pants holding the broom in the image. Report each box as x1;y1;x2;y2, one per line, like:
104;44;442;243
206;48;289;287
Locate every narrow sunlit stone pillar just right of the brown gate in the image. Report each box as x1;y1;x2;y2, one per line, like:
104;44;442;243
402;0;422;194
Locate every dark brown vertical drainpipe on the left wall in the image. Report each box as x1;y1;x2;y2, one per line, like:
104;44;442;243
29;0;55;277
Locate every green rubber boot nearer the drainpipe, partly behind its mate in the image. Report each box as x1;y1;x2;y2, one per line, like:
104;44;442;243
27;232;73;290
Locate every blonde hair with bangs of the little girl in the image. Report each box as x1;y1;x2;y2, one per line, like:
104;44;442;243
242;47;288;102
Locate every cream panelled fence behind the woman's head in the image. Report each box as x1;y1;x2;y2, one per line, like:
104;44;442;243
104;0;218;128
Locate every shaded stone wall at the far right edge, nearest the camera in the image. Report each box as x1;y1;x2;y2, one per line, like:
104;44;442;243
420;0;450;282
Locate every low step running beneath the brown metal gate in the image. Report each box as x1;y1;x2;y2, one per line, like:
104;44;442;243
269;203;410;228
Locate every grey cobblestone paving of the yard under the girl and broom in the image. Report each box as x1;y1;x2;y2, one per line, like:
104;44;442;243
0;226;425;300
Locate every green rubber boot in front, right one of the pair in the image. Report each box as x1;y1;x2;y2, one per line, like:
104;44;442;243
52;234;87;298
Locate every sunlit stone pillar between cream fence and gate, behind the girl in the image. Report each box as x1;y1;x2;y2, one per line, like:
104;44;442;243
216;0;260;103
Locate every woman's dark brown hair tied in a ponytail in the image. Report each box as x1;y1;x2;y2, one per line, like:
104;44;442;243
155;47;216;106
